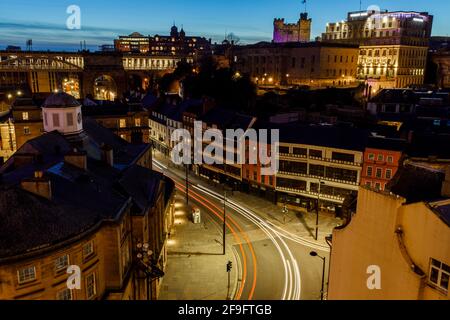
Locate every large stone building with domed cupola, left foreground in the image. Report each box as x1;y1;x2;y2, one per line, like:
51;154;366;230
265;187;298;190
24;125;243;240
0;94;174;300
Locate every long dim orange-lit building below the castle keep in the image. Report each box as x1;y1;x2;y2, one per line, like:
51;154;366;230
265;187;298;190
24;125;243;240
236;42;358;87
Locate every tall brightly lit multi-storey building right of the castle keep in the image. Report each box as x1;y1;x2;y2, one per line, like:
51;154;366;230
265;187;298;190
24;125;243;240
322;10;433;93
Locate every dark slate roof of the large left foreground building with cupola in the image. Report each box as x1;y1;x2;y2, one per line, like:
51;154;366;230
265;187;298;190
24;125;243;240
0;113;168;260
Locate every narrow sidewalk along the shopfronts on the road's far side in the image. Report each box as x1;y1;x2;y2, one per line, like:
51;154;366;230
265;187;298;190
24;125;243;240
155;154;343;246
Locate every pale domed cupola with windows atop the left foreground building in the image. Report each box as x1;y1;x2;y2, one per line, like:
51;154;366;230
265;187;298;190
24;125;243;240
42;92;83;135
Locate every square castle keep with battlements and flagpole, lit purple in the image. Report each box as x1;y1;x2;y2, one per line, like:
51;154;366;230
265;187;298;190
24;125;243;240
273;12;312;43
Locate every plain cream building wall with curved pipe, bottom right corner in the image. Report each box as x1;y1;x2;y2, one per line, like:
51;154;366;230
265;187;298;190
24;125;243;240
328;162;450;300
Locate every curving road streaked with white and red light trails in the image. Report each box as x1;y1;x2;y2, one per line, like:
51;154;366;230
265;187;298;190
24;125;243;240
153;160;329;300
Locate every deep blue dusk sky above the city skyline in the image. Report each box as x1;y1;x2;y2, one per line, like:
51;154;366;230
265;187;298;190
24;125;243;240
0;0;450;50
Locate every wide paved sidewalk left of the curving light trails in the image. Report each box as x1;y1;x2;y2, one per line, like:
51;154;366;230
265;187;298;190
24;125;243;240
159;193;239;300
